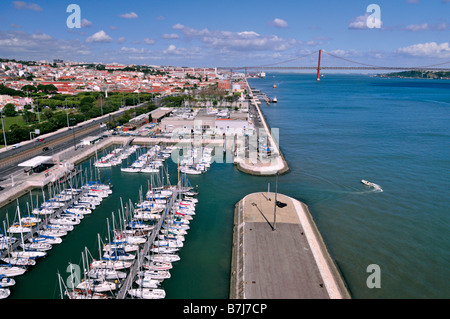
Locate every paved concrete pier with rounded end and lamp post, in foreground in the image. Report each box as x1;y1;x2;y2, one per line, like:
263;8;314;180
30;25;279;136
230;193;350;299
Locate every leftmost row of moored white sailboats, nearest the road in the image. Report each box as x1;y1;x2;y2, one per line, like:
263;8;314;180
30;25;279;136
0;173;112;296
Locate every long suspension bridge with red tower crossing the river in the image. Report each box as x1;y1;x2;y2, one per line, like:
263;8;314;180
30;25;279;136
218;50;450;81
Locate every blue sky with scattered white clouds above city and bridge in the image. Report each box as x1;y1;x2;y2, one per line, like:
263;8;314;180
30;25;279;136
0;0;450;67
